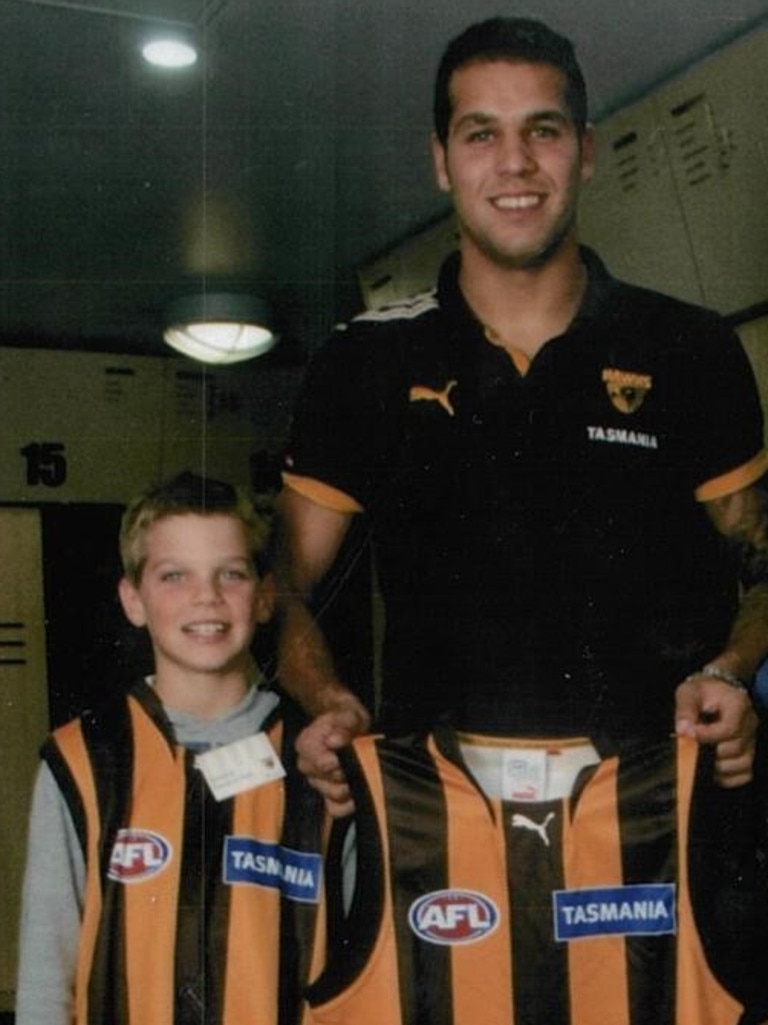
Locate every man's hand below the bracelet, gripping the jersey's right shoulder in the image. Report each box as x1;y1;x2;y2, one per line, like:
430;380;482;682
675;675;758;787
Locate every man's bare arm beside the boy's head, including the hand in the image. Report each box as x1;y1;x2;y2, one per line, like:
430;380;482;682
276;487;370;817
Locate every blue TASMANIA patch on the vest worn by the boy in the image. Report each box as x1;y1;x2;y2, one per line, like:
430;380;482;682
224;836;322;904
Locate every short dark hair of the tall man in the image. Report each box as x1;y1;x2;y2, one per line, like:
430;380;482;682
433;17;588;146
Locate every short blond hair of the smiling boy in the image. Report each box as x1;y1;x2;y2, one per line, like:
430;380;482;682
120;470;271;585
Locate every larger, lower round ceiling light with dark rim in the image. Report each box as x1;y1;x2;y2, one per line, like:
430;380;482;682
164;292;277;364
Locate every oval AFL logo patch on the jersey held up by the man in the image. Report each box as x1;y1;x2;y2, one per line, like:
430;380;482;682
408;890;499;946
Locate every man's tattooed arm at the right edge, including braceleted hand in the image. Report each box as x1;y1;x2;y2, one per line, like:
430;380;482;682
676;485;768;786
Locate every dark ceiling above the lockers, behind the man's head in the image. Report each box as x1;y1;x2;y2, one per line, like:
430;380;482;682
0;0;768;353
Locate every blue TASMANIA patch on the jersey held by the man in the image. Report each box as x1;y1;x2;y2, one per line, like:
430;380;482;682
553;883;677;941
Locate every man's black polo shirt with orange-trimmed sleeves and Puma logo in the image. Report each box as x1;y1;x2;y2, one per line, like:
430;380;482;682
287;250;765;736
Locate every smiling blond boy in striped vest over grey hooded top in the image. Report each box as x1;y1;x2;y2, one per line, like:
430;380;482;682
16;473;323;1025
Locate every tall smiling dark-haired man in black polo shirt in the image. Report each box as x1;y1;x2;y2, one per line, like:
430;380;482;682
274;18;768;811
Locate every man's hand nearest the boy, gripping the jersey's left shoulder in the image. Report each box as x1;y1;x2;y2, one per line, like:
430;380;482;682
296;695;370;818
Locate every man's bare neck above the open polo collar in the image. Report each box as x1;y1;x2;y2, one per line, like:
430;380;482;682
459;243;587;359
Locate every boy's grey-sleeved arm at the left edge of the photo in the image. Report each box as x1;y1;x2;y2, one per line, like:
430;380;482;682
15;764;85;1025
